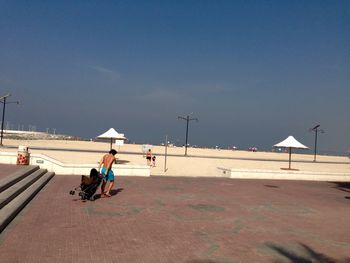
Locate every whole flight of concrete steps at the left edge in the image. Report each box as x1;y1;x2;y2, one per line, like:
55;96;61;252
0;165;54;233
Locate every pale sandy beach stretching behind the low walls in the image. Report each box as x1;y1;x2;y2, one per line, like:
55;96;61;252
0;139;350;176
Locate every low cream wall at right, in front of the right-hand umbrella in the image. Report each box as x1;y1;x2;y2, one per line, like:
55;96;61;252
218;167;350;182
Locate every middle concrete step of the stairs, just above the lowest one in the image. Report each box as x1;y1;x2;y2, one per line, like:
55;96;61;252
0;169;47;209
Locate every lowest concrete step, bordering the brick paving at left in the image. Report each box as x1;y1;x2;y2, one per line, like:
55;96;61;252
0;172;54;233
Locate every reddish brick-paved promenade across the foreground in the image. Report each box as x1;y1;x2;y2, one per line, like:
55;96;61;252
0;165;350;263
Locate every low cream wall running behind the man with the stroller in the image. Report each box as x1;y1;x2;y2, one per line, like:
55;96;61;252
0;152;151;176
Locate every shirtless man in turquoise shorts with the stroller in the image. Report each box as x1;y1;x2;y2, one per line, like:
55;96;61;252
98;149;117;197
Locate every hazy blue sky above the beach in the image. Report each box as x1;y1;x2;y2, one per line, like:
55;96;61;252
0;0;350;155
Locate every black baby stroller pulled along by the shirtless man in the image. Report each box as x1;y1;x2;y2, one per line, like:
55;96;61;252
69;168;102;201
